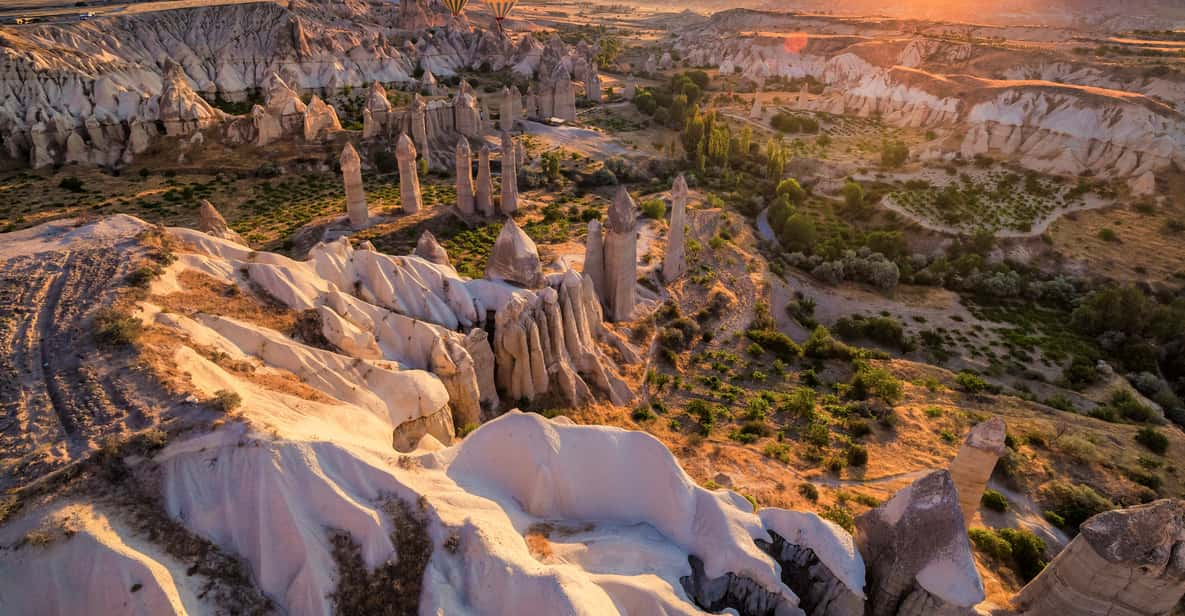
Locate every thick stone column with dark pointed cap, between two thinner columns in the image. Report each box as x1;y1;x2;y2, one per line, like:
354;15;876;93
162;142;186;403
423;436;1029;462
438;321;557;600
604;186;638;321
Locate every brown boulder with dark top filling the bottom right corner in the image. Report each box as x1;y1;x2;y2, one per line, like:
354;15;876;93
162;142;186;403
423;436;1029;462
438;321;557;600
1013;500;1185;616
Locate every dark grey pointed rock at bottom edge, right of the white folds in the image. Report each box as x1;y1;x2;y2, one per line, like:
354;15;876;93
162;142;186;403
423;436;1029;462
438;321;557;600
856;470;984;616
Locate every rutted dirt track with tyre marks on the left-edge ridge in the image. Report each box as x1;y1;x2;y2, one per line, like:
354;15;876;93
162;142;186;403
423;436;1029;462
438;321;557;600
0;246;164;488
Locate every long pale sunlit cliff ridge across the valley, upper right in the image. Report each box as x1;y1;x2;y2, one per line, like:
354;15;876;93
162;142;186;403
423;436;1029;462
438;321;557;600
677;27;1185;179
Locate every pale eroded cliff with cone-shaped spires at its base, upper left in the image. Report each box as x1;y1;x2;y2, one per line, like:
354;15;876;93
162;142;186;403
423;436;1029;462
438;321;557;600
0;1;592;168
